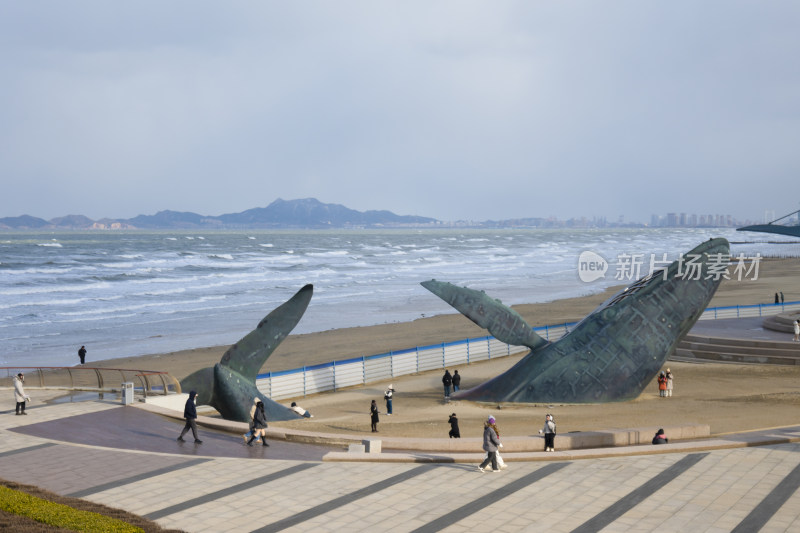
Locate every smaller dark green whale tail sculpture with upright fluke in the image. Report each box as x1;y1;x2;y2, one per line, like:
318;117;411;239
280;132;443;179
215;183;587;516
181;284;314;422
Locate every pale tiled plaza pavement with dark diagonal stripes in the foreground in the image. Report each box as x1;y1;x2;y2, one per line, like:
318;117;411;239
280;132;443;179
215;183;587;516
0;402;800;533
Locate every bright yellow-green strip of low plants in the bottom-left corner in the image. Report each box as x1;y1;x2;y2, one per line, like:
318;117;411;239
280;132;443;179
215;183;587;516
0;486;144;533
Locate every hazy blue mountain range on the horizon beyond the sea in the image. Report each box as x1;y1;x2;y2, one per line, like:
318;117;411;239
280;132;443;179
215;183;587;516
0;198;440;230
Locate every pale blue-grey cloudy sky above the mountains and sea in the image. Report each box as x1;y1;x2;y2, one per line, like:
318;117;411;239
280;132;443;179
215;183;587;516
0;0;800;222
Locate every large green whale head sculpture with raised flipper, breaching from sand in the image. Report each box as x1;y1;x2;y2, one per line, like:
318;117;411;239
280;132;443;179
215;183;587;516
422;239;730;403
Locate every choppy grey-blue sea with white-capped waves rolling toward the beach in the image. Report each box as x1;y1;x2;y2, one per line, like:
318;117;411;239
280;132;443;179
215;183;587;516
0;229;798;366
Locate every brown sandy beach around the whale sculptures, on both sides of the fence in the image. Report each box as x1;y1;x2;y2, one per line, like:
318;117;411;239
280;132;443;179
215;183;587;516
88;259;800;437
